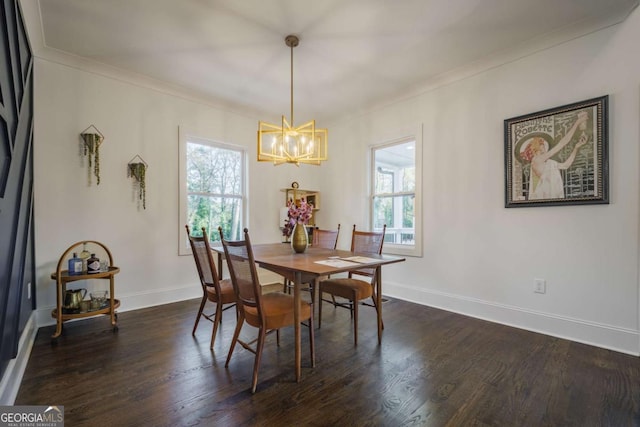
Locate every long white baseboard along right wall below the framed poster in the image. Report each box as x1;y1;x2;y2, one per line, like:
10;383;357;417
384;282;640;356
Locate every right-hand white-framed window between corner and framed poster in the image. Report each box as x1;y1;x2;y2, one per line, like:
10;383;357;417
371;132;422;256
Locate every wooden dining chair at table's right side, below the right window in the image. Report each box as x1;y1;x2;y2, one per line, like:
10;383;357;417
318;224;387;345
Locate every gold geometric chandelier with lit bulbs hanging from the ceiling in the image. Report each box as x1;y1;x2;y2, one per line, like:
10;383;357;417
258;35;327;166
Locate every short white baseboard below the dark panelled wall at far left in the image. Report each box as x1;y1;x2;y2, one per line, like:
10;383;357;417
0;312;38;405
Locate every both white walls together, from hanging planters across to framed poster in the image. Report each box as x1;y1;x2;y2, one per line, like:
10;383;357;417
34;10;640;354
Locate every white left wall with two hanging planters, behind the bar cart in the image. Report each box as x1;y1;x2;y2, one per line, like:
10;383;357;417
34;58;319;325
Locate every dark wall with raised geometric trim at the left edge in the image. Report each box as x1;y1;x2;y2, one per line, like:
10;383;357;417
0;0;35;382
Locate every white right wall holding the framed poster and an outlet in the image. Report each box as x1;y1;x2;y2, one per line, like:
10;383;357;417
327;10;640;354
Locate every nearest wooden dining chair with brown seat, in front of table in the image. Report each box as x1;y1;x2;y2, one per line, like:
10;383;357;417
218;228;315;393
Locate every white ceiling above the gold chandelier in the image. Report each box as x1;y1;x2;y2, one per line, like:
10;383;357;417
21;0;638;123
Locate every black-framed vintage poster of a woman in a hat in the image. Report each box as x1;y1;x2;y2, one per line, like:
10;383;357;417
504;95;609;208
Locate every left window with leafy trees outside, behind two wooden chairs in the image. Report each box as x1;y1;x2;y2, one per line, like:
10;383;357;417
180;132;245;255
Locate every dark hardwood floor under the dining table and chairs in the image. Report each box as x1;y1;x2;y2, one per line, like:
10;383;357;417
15;300;640;426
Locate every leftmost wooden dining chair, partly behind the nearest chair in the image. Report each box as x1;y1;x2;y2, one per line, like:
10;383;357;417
185;225;236;348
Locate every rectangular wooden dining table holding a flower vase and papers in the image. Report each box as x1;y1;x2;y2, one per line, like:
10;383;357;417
213;243;405;382
